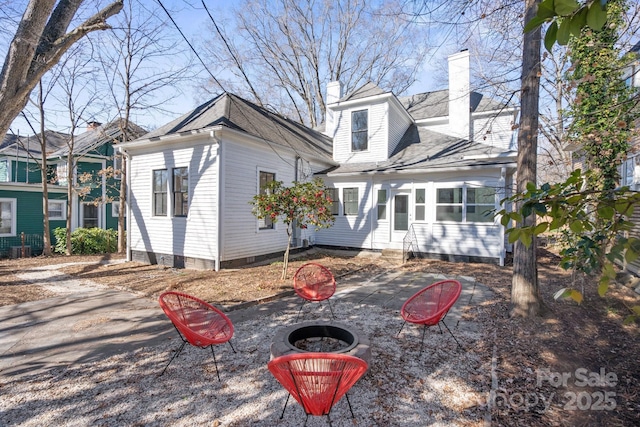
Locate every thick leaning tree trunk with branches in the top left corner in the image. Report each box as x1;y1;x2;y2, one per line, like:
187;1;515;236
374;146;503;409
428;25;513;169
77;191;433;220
0;0;122;136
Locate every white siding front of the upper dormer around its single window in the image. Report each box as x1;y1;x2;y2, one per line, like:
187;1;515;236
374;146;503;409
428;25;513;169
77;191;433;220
333;101;389;163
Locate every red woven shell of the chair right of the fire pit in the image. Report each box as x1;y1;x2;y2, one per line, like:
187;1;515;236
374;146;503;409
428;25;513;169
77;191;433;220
400;280;462;326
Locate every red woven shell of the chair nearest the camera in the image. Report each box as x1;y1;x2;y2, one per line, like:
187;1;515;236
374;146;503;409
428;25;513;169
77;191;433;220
267;353;368;415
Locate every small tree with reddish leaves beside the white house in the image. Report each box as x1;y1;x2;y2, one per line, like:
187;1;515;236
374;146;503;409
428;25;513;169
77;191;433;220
250;178;334;280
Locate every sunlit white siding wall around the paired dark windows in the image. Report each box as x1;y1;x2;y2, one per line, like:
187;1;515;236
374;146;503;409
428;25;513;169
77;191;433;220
128;142;218;260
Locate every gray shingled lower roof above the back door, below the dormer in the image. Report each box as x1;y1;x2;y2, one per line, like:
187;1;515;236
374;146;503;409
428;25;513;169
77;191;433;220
325;125;515;175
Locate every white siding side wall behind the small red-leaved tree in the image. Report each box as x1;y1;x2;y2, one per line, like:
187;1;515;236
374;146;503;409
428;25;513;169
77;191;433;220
221;141;295;261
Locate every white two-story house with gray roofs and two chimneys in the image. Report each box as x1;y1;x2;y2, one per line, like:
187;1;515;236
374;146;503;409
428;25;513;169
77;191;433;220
121;51;516;269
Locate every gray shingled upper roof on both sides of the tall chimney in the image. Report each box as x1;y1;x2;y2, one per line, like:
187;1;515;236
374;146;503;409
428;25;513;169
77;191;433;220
398;89;506;120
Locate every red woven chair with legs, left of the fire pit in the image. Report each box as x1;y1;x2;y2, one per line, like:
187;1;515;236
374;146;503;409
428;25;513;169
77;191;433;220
159;291;236;381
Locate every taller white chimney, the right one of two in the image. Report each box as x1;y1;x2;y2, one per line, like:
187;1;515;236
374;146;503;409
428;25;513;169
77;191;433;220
449;49;471;139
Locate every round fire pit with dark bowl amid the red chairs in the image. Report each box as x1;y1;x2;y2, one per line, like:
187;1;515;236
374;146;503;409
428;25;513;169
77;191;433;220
271;321;371;363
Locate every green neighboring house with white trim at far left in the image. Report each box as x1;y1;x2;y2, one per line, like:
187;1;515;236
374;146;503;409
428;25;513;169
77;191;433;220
0;121;146;257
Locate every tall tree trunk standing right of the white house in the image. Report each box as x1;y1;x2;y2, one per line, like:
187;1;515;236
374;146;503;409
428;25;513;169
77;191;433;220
511;0;542;317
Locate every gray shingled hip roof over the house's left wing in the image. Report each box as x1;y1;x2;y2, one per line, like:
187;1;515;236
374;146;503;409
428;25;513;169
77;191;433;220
141;93;333;162
